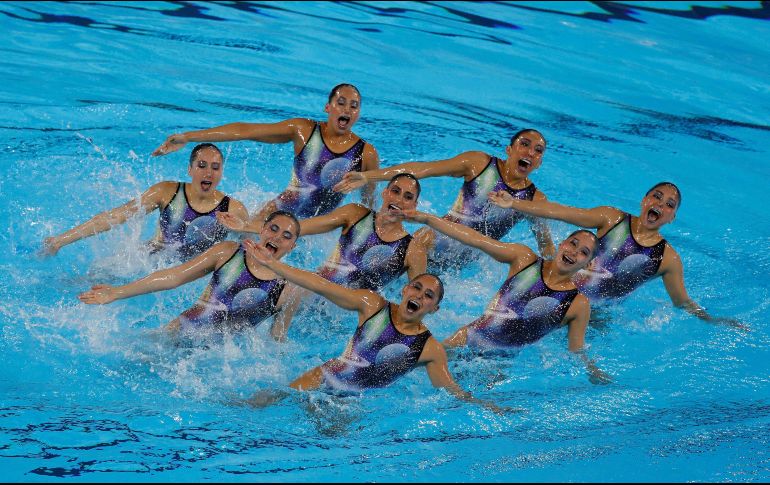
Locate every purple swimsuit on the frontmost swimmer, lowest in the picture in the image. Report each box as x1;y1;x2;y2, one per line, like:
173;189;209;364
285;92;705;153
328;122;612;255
321;302;431;392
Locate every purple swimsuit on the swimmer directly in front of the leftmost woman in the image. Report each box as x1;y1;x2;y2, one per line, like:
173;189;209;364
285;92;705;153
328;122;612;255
179;246;286;330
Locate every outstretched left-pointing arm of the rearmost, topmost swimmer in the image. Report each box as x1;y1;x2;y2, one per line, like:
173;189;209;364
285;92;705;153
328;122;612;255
152;118;313;157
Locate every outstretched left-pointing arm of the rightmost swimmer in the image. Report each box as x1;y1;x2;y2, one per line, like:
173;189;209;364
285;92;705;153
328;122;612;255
488;191;623;231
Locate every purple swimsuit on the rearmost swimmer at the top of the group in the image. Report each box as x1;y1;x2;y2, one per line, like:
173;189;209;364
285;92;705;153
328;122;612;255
275;122;366;219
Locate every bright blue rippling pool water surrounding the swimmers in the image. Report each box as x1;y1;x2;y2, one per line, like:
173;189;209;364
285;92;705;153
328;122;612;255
0;2;770;481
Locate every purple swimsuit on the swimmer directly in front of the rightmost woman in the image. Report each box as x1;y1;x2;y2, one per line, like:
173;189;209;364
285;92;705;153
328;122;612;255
467;258;578;349
